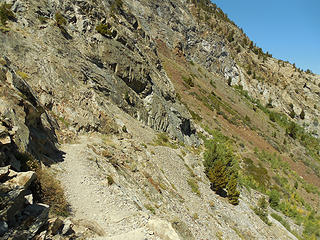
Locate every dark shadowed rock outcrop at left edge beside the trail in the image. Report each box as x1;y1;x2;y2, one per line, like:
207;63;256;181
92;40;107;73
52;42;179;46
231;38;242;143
0;60;58;167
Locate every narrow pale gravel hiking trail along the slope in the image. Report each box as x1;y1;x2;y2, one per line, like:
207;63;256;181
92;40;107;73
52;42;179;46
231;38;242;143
55;136;153;240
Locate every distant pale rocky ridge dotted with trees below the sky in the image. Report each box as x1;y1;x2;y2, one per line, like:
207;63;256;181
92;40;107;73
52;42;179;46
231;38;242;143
126;0;320;136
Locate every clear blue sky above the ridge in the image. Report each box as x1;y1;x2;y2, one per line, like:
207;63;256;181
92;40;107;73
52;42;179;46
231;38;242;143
212;0;320;74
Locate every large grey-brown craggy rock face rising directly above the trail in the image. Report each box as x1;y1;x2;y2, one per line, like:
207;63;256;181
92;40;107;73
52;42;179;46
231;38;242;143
1;1;197;144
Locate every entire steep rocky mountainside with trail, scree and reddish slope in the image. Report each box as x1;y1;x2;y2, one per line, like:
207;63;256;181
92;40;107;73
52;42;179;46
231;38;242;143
0;0;320;239
